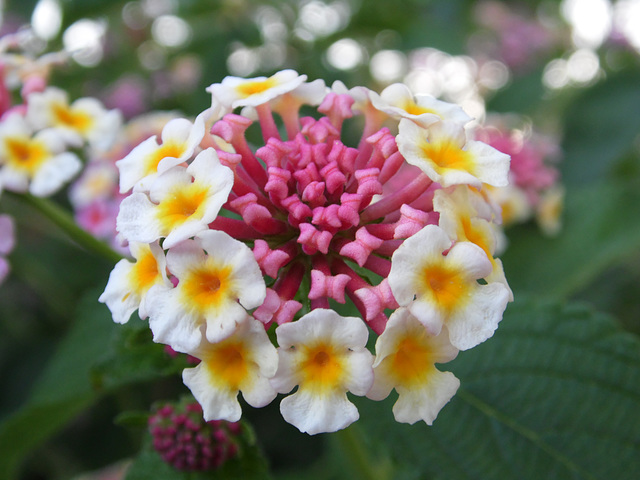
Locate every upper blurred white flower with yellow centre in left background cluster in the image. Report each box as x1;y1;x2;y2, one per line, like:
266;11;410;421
27;87;122;151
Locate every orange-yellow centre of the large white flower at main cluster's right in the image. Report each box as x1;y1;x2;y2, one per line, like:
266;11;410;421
422;263;469;313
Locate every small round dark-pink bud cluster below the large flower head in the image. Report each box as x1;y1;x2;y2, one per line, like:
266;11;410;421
149;401;242;471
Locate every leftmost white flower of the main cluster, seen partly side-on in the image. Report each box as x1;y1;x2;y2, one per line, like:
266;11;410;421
98;242;171;323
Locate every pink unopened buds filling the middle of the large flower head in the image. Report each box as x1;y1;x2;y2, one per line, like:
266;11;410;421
211;92;437;333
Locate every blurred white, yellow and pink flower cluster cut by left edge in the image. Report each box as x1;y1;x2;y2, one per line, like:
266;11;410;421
0;33;122;281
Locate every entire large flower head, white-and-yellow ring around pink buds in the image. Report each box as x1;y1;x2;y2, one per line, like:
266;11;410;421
100;70;512;434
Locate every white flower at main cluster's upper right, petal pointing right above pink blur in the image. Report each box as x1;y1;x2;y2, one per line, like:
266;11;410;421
396;118;509;188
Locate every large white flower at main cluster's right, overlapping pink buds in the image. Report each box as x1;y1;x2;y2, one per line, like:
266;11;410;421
388;225;509;350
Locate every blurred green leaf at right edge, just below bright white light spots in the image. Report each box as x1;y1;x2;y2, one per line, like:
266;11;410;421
560;68;640;185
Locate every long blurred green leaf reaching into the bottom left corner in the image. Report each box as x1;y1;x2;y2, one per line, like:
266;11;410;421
0;290;179;478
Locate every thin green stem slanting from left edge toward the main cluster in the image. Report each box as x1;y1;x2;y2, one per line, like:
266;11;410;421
8;191;123;263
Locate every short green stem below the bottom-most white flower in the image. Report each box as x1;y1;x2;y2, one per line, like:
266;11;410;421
334;424;393;480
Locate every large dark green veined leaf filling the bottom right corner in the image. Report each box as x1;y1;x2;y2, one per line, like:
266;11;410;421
360;302;640;480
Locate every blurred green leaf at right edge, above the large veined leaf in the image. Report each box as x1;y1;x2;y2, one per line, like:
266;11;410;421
502;182;640;298
